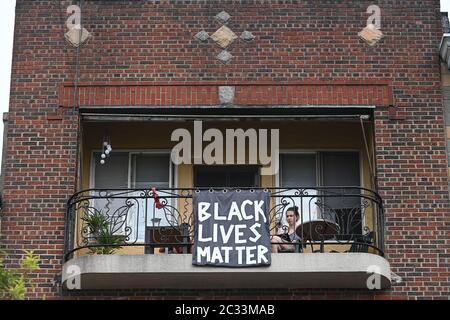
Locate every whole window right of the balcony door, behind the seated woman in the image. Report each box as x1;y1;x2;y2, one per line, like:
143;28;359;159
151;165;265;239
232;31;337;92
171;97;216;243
280;152;362;234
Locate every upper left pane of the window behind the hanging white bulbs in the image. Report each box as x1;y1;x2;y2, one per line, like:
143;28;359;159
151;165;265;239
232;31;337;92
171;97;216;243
94;152;128;189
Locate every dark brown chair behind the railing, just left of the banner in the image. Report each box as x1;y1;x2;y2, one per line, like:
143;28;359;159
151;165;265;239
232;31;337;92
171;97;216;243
145;223;190;254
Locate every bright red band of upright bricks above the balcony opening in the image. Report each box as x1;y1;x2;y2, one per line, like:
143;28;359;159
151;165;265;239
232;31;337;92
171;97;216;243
59;81;393;107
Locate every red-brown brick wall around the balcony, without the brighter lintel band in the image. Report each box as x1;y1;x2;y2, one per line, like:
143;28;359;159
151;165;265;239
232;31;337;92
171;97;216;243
1;0;450;299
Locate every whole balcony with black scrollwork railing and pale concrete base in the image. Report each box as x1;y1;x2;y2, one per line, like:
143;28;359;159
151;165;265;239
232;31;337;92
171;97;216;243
63;187;391;290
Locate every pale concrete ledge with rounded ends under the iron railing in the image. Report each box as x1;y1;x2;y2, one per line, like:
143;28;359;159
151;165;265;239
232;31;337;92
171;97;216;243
63;253;391;290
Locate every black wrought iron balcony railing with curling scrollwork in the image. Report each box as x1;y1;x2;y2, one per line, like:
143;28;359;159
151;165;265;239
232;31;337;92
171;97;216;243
65;187;384;260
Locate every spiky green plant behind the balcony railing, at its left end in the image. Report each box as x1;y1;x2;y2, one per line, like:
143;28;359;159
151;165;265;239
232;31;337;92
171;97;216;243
82;211;126;254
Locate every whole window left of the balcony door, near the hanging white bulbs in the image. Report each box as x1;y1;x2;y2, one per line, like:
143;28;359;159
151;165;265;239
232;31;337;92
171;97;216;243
93;151;175;242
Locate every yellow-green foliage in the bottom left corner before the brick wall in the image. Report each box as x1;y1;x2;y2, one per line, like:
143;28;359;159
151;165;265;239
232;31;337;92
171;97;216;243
0;249;39;300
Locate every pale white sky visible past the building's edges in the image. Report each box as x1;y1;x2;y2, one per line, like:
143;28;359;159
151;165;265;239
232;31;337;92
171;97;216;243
0;0;450;175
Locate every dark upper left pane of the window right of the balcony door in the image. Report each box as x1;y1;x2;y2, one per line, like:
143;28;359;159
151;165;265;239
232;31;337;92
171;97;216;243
281;154;317;188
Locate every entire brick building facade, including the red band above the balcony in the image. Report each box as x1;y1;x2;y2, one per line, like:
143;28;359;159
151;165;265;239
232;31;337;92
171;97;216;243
1;0;450;299
